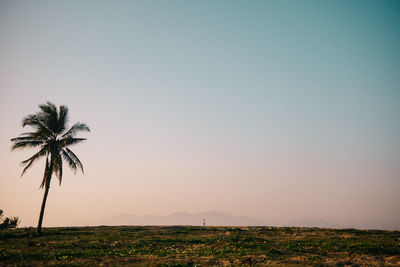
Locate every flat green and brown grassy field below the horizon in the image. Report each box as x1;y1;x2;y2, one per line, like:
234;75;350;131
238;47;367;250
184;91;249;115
0;226;400;266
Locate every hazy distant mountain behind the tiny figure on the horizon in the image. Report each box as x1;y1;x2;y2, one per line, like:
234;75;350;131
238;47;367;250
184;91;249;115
96;211;266;226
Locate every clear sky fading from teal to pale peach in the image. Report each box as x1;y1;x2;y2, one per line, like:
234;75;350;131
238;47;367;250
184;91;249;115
0;0;400;229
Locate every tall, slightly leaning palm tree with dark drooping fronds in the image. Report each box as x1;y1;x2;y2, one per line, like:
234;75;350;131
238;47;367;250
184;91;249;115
11;102;90;233
